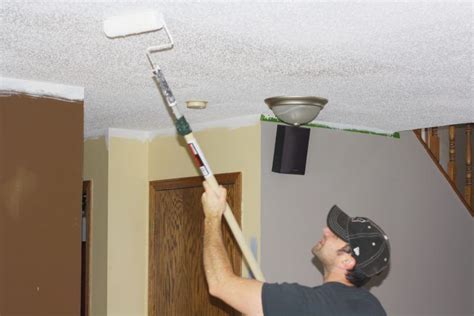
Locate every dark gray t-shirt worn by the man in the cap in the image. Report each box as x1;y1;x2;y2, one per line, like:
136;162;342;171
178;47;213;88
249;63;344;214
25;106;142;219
262;282;387;316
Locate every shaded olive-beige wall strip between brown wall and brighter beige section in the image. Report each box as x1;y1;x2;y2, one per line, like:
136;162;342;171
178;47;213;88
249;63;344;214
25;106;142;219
83;137;109;316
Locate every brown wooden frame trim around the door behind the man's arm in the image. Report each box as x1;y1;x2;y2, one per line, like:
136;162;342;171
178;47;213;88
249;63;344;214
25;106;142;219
148;172;242;316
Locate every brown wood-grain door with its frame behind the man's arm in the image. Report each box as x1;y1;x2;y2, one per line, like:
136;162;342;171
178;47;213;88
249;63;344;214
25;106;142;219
148;173;242;316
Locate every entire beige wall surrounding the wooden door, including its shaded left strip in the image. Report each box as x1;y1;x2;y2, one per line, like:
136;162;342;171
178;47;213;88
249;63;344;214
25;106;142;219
84;124;260;316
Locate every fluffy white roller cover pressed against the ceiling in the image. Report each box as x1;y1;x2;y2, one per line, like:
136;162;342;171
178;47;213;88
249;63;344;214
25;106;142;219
104;11;164;38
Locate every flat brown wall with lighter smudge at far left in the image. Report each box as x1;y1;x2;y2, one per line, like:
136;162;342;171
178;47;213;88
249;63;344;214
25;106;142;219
0;96;83;316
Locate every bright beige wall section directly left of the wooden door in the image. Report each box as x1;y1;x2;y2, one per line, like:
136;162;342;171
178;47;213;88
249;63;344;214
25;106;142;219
107;137;148;315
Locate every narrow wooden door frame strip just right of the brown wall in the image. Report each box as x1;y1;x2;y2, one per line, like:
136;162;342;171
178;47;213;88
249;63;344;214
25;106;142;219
81;180;92;316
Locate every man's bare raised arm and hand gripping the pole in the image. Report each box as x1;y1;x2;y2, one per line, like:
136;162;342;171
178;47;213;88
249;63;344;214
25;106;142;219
202;182;263;315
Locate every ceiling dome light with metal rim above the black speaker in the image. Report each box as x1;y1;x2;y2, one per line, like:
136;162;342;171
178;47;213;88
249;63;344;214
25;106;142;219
264;96;328;126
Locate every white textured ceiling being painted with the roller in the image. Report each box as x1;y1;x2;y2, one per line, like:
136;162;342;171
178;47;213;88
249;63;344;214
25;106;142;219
0;1;474;135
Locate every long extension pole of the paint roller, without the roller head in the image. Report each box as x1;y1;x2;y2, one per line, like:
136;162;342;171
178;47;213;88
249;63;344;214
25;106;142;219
152;63;265;282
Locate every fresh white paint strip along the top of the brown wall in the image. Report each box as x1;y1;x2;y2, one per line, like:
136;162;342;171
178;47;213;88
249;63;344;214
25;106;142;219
0;77;84;101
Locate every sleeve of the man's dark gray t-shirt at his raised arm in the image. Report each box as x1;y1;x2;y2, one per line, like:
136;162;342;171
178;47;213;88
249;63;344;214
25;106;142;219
262;283;307;316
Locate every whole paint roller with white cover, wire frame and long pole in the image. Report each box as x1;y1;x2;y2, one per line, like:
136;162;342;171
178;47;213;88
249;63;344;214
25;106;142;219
104;11;265;282
